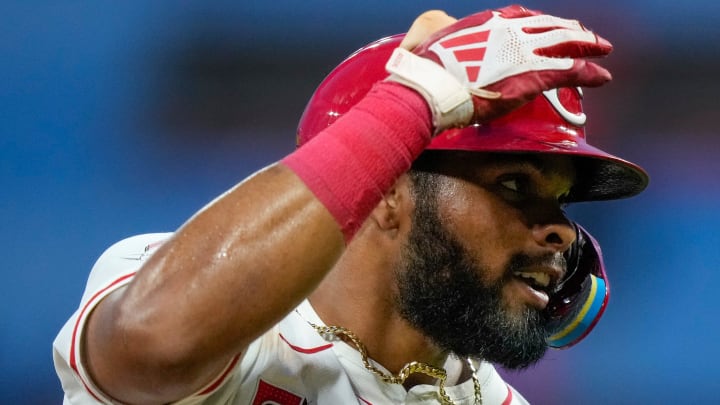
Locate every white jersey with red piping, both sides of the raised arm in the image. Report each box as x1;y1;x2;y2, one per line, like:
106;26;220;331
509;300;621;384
53;233;527;405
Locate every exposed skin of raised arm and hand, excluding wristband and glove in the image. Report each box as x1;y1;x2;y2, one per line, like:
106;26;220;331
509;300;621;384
82;12;455;403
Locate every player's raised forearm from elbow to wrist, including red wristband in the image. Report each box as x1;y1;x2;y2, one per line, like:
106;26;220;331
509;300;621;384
86;79;431;401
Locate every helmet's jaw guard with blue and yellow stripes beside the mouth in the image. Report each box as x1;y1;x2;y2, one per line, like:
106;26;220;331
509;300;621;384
546;224;610;348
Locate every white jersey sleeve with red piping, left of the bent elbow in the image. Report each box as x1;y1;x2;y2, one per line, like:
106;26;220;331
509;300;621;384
53;233;172;405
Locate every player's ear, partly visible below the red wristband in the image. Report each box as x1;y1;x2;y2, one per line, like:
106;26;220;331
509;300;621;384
370;174;412;233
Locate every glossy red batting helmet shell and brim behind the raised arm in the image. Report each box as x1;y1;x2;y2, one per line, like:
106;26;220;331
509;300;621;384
297;35;648;202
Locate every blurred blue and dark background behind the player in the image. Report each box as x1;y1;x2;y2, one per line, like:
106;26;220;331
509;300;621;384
0;0;720;404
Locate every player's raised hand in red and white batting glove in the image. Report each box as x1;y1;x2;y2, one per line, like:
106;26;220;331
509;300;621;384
388;6;612;129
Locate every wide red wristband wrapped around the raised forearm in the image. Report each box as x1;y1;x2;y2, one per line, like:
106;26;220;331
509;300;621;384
282;82;432;241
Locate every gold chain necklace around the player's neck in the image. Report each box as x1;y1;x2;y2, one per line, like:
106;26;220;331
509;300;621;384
308;322;482;405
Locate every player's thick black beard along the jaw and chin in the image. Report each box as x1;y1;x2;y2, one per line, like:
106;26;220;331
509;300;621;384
396;194;547;369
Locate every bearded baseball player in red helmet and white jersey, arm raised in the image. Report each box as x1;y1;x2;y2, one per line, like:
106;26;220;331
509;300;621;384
54;6;648;405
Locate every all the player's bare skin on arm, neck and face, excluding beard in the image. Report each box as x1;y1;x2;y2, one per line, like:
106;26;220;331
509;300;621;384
81;11;596;403
